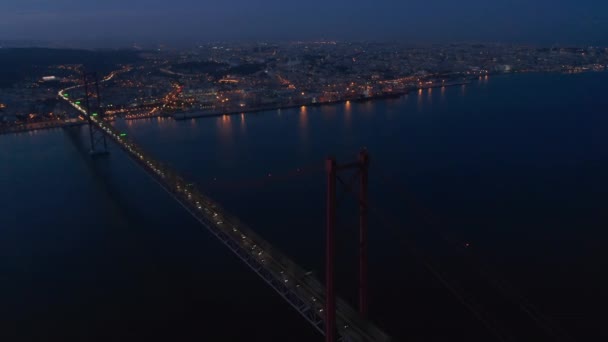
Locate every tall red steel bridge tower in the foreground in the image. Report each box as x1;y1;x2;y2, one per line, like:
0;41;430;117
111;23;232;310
325;150;369;342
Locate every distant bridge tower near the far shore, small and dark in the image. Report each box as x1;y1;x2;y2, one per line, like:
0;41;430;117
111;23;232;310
82;72;108;156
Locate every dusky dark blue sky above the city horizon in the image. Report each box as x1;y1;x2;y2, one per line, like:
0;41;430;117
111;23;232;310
0;0;608;45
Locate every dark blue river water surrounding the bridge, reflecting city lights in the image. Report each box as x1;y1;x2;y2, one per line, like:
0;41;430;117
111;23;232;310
0;74;608;341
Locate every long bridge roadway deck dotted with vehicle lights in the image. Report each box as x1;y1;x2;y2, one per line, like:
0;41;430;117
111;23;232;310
60;94;391;342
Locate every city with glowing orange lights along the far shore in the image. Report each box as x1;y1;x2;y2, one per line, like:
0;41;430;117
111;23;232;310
0;41;608;130
